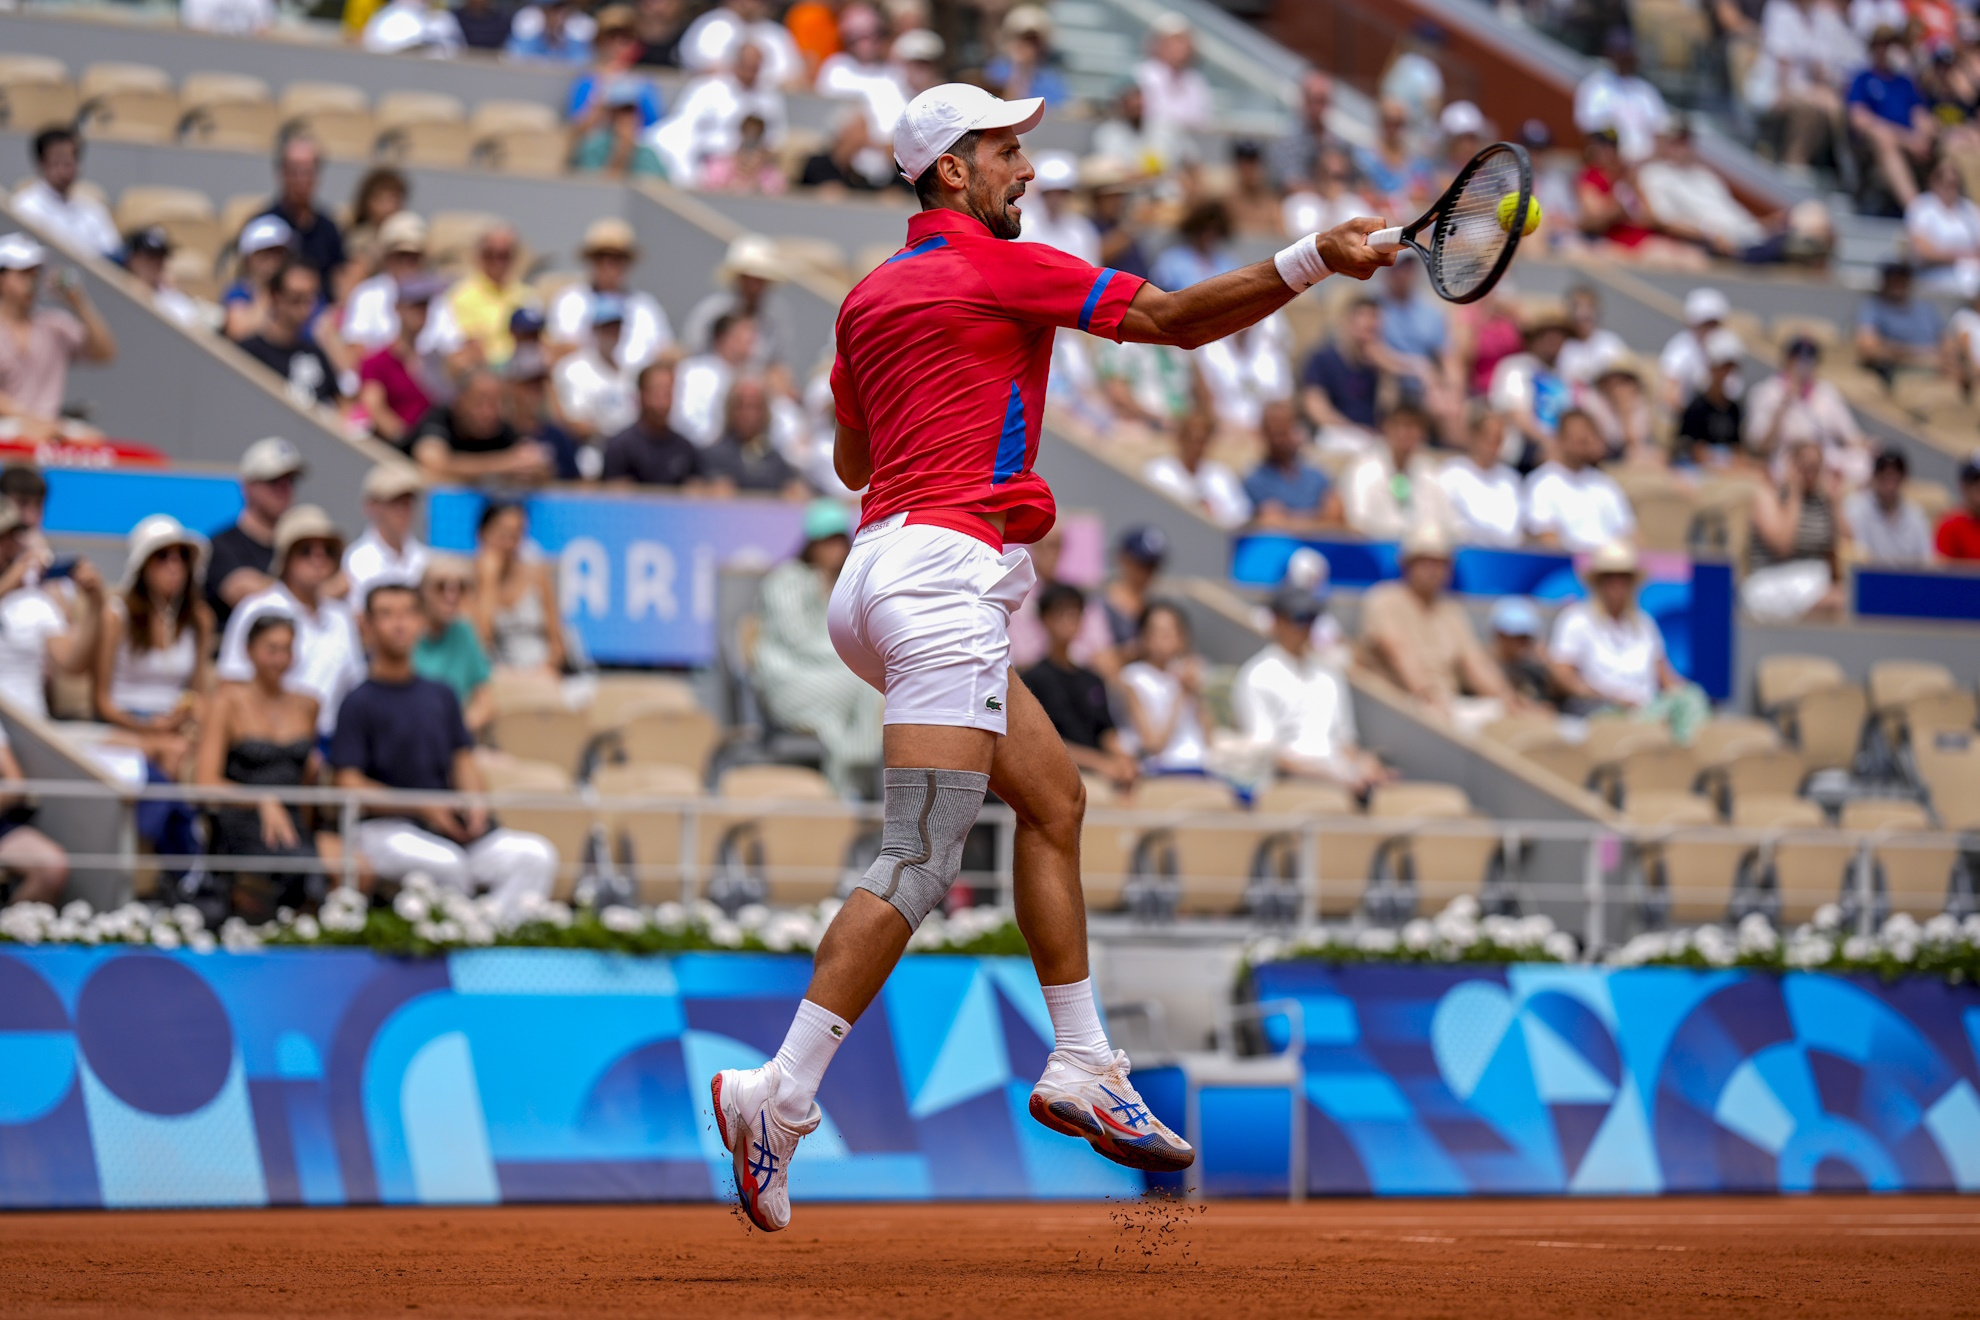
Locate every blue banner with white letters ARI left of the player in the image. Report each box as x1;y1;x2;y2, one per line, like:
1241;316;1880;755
428;491;804;667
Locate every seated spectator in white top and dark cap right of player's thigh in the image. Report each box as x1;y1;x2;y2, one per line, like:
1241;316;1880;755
1232;588;1394;794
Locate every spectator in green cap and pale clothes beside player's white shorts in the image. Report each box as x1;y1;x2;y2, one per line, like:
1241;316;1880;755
750;499;881;798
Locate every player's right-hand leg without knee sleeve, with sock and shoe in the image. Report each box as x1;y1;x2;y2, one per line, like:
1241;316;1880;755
990;675;1196;1172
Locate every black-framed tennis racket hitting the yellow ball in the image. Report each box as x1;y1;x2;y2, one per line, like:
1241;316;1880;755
1368;142;1533;303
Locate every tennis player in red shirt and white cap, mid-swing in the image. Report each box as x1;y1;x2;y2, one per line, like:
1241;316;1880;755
711;83;1394;1231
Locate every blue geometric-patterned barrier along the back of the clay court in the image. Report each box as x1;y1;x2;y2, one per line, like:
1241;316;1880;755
0;946;1980;1207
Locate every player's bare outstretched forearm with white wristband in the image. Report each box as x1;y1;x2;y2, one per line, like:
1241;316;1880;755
1121;216;1396;348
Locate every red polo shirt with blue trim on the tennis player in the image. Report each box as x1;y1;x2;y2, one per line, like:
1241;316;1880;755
832;210;1146;550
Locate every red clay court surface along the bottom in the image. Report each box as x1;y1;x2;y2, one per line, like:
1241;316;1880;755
0;1197;1980;1320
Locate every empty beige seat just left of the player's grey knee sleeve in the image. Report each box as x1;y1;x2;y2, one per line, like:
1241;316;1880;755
701;766;859;904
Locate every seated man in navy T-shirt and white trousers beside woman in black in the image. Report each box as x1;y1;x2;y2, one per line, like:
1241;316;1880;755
331;582;556;918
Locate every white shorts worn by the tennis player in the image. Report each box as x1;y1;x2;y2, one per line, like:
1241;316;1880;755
826;513;1036;734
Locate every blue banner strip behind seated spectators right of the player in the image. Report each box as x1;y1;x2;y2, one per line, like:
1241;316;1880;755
1232;532;1726;701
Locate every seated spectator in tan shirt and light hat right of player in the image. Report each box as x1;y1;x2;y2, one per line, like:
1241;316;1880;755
1362;524;1513;732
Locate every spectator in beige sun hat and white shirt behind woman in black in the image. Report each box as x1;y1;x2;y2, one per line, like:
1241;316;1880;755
216;505;364;736
